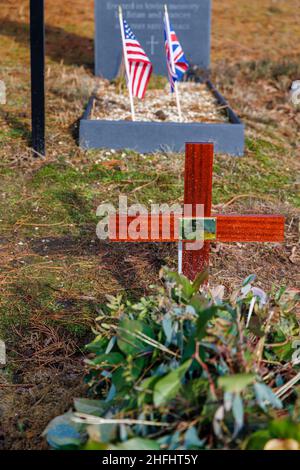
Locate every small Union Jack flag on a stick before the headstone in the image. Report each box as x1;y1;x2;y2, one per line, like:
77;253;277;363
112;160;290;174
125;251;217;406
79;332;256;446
165;15;190;93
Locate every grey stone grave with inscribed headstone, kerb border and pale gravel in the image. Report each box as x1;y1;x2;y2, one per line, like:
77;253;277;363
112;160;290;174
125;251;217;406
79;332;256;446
80;0;244;156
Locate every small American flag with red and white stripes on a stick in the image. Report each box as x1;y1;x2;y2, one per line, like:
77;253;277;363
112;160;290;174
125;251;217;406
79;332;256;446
123;20;153;99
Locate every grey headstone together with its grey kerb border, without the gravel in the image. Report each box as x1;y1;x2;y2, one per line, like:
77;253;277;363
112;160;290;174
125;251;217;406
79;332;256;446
79;0;245;156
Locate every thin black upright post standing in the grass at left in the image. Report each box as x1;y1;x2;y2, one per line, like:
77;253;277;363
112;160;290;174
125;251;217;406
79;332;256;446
30;0;45;156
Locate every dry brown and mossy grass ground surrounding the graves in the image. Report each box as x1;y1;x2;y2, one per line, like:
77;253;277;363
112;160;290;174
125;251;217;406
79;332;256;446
0;0;300;448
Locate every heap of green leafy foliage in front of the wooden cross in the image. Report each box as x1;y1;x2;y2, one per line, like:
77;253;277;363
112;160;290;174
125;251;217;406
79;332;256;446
45;270;300;450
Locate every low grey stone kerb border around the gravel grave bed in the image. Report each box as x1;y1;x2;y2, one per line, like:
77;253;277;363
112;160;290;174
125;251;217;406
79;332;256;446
79;80;245;156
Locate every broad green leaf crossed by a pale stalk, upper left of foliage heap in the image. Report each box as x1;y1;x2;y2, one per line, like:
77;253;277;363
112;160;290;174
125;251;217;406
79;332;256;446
117;319;154;356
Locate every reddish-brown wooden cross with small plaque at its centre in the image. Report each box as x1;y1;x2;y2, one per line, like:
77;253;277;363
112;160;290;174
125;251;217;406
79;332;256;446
109;143;285;280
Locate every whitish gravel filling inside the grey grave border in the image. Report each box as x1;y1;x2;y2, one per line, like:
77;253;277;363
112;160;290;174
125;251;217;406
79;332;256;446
92;81;228;123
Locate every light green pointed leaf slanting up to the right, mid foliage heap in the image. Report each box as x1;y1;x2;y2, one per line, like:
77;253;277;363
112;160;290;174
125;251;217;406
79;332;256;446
153;359;192;406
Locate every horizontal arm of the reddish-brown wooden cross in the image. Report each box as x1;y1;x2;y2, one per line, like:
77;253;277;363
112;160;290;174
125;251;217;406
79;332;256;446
109;214;285;243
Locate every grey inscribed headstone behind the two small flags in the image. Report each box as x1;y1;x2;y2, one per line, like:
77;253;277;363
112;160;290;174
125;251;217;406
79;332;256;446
95;0;211;80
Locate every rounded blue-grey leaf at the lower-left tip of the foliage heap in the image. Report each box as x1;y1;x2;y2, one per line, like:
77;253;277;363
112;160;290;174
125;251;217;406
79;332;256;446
43;413;86;450
